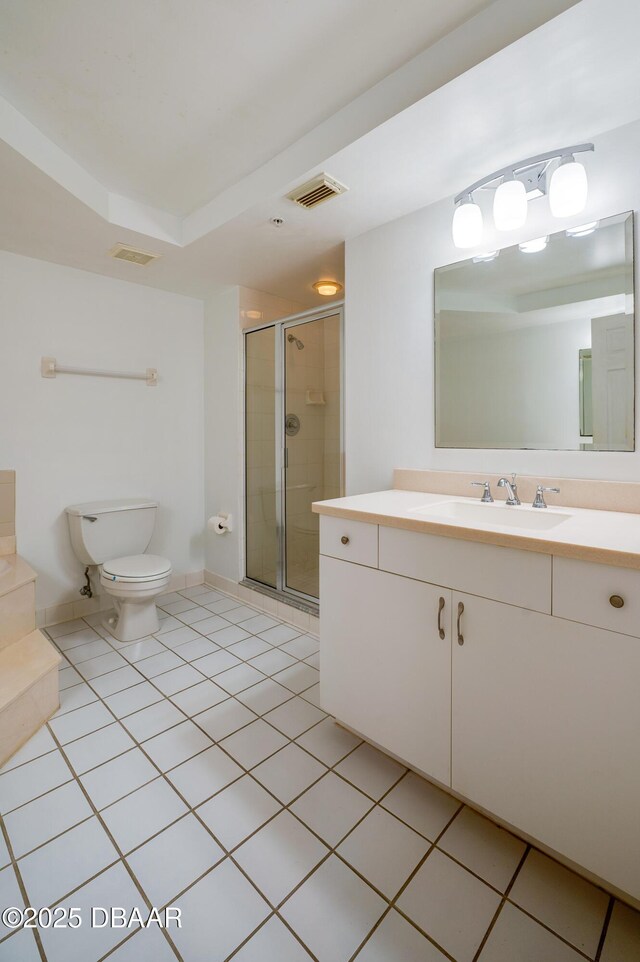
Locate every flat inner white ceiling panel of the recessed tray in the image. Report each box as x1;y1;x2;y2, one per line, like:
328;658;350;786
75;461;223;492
0;0;492;214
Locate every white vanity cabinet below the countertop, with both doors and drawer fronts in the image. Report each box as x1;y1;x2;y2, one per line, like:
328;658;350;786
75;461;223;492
320;517;640;899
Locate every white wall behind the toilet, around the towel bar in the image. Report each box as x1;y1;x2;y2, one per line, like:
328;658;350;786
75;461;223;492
0;252;204;609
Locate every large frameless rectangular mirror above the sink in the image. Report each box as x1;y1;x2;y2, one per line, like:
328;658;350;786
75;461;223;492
434;213;635;451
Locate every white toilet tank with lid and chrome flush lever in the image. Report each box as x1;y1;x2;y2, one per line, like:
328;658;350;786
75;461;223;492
65;498;158;565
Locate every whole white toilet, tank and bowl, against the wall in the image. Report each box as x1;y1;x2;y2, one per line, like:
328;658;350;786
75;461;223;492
66;498;171;641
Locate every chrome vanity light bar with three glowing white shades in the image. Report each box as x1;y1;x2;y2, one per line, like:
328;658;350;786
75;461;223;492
452;144;594;249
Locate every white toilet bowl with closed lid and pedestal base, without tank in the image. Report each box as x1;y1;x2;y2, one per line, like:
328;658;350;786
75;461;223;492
100;554;171;641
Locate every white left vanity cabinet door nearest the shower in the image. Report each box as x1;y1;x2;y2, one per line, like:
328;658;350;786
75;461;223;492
320;557;451;785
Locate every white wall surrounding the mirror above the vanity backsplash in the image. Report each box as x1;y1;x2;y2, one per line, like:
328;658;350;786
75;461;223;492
345;123;640;494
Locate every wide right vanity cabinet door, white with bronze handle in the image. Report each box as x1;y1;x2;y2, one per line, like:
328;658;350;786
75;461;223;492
452;593;640;898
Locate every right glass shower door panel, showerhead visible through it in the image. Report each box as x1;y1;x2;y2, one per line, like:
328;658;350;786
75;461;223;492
282;313;341;599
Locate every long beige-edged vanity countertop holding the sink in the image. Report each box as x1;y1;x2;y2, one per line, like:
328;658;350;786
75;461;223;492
313;489;640;569
